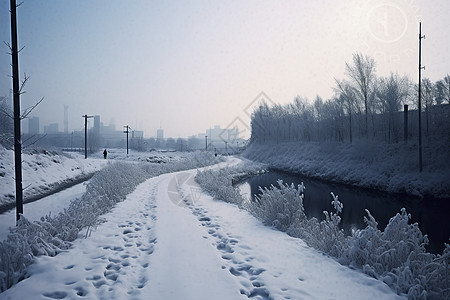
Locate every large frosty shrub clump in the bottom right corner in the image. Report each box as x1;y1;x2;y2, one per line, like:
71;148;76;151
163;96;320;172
342;209;450;299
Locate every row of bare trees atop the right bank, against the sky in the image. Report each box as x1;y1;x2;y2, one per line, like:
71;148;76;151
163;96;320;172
251;53;450;143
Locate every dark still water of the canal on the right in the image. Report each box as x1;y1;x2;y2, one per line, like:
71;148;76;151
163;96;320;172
239;170;450;253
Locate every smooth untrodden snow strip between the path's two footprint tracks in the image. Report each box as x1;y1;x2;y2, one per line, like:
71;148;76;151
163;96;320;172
142;172;243;299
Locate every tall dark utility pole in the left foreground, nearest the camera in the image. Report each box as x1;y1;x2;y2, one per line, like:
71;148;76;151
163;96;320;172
10;0;23;221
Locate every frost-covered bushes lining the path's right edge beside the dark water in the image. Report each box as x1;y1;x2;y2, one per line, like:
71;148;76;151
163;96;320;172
199;164;450;299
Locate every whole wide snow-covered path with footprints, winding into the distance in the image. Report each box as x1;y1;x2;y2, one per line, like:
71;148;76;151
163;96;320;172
0;161;398;299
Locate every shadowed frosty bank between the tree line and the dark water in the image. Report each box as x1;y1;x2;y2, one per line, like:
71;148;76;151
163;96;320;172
244;140;450;198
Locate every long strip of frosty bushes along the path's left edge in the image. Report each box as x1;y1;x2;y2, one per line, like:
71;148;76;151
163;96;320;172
0;152;223;291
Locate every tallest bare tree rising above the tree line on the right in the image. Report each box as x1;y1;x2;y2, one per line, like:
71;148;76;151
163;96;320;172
345;53;375;136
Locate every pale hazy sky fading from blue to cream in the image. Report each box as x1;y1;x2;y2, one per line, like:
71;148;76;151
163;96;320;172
0;0;450;137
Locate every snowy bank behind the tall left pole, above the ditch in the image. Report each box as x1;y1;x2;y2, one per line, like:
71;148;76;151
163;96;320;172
0;146;106;211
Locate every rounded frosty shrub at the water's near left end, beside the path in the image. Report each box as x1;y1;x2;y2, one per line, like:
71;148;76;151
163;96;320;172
248;180;305;231
